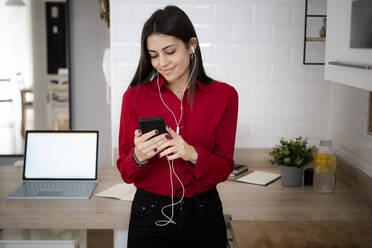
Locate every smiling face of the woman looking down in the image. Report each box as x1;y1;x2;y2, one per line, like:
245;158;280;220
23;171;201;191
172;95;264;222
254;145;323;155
147;33;191;85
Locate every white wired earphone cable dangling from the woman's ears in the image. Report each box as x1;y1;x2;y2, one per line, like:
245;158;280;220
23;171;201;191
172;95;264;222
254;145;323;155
155;46;196;226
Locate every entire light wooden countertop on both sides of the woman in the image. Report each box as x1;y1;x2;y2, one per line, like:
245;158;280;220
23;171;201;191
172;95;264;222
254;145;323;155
0;166;372;229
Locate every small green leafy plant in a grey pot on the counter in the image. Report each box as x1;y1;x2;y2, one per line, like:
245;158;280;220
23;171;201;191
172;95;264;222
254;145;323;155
269;136;316;187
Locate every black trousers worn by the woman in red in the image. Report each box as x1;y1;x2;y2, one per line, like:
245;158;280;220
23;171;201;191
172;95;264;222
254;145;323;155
128;188;227;248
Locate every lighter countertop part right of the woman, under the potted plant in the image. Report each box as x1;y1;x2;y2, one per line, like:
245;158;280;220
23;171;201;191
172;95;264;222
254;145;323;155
218;167;372;221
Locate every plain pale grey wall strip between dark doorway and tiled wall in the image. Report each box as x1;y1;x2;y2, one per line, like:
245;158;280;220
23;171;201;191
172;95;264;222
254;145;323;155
70;0;112;165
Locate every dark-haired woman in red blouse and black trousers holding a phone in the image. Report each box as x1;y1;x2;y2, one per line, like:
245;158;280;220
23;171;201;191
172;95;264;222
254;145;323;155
117;6;238;248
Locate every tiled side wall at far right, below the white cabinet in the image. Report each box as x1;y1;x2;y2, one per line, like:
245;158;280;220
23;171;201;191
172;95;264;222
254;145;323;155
329;83;372;177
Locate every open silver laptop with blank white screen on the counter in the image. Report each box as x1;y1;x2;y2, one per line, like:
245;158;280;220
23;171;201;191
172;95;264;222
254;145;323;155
7;130;98;199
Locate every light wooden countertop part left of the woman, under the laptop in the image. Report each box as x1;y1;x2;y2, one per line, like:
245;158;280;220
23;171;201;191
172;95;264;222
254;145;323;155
0;166;131;229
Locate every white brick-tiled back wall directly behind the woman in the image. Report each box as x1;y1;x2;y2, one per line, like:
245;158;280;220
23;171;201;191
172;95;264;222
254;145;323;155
111;0;330;155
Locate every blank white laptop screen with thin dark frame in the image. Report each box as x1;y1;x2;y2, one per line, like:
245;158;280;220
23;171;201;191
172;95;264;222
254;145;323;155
23;131;98;180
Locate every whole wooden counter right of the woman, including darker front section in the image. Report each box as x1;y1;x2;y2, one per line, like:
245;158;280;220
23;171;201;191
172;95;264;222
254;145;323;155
219;168;372;248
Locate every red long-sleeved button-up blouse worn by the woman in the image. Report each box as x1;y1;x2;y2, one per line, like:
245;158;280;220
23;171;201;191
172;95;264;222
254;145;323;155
117;76;238;197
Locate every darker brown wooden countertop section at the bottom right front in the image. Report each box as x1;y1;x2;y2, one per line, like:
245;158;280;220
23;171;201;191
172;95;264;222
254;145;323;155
231;221;372;248
